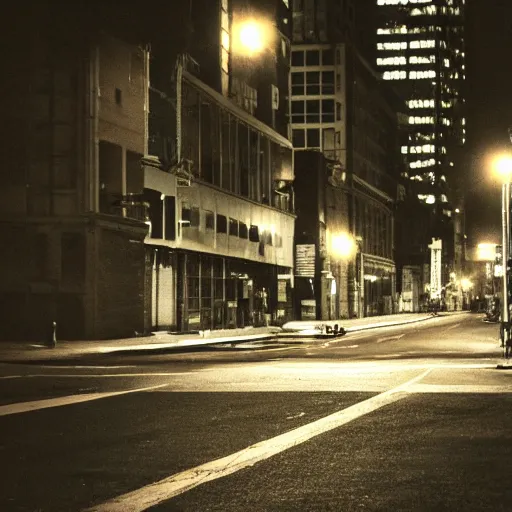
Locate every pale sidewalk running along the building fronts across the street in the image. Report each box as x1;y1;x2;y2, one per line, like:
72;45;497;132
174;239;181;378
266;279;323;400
0;312;466;363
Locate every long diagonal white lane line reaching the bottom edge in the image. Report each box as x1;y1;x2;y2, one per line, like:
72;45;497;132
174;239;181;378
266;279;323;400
87;369;431;512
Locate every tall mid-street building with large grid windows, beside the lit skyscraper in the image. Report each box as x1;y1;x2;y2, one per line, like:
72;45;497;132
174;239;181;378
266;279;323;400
290;0;402;317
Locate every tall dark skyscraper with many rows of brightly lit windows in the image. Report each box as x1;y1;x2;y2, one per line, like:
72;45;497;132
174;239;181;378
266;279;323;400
372;0;466;303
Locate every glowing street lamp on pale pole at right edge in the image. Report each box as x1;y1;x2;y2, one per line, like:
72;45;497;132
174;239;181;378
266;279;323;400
494;155;512;360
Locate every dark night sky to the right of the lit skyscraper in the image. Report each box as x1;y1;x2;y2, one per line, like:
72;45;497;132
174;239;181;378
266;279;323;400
464;0;512;245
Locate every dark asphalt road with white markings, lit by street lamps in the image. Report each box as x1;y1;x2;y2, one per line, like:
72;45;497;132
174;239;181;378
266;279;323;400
0;315;512;512
